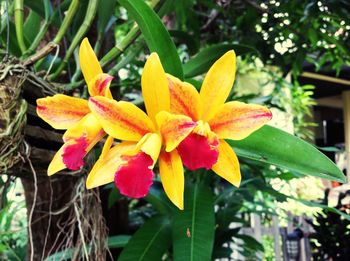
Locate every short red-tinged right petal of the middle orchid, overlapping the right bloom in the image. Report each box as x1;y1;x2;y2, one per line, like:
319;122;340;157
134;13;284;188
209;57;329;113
156;111;196;152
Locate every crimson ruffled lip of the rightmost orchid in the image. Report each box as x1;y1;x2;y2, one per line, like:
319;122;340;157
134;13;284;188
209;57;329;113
177;133;219;170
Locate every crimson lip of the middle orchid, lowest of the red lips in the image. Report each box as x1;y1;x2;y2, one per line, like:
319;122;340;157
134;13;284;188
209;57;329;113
114;152;153;198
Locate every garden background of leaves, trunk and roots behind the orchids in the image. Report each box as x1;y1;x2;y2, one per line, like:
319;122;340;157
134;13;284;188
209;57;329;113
0;0;350;260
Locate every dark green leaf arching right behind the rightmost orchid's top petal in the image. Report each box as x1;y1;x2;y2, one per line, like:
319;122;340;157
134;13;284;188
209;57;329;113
183;44;256;78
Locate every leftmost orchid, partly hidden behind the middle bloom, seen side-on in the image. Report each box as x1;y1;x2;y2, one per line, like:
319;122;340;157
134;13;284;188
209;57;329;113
36;38;113;176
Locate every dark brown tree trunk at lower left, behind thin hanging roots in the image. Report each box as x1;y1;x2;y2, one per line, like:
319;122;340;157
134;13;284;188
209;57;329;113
21;173;77;260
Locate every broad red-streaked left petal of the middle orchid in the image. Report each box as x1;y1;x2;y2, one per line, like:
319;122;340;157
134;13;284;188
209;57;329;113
89;96;154;141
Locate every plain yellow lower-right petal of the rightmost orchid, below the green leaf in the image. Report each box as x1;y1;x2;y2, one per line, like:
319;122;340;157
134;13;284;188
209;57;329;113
211;140;241;187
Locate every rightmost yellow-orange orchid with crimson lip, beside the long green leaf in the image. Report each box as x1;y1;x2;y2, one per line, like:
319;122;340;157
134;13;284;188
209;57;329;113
166;50;272;187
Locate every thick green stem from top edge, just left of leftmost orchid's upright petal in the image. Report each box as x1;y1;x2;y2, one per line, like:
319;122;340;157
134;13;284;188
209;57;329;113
49;0;99;81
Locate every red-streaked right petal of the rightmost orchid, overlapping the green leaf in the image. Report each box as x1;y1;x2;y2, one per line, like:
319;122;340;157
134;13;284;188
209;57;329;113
209;102;272;140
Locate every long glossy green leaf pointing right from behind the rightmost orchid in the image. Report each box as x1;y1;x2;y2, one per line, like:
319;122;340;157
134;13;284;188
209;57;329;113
228;126;346;183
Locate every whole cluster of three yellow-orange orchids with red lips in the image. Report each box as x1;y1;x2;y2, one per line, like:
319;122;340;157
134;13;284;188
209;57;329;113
37;39;272;209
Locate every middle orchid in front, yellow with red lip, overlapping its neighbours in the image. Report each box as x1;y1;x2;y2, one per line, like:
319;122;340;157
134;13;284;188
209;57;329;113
86;53;196;209
